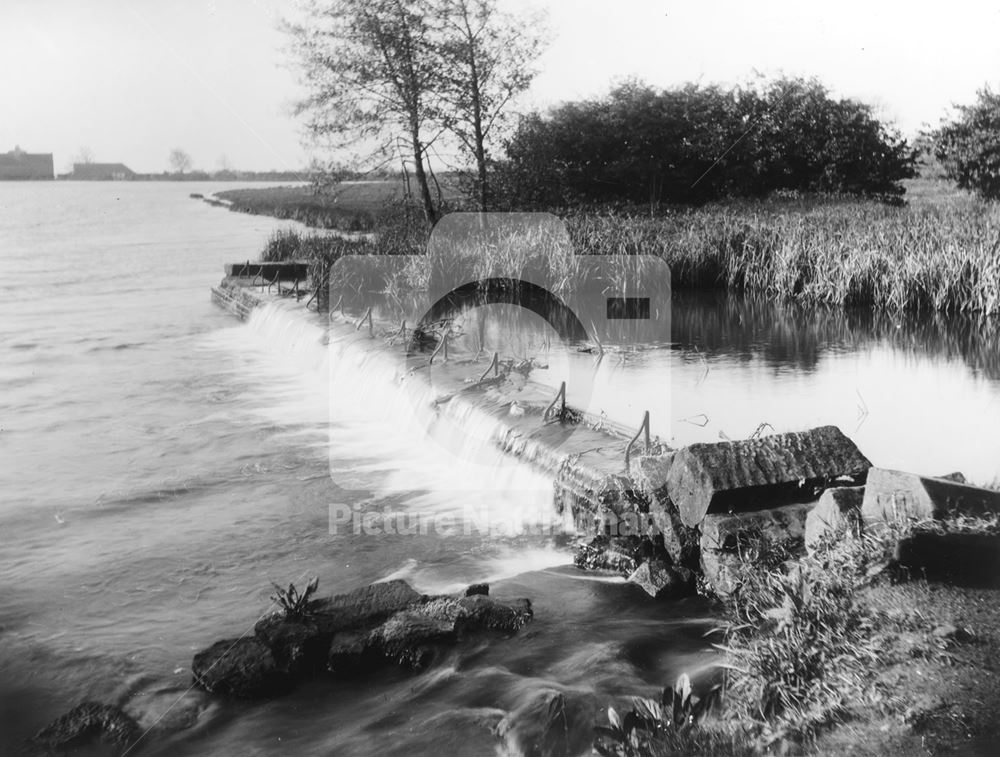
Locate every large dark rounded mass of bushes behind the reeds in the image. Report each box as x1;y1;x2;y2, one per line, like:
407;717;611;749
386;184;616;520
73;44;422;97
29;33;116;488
496;79;915;207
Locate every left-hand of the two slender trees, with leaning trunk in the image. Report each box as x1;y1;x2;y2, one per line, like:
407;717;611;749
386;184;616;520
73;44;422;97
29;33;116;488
286;0;441;223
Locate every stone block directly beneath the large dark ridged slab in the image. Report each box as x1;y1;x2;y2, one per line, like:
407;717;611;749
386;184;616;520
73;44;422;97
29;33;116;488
701;502;814;597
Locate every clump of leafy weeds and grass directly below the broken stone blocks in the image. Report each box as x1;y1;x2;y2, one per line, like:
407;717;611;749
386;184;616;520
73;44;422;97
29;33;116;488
722;531;897;745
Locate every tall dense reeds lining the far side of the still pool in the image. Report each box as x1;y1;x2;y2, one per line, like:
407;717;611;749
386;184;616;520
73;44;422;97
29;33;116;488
569;196;1000;315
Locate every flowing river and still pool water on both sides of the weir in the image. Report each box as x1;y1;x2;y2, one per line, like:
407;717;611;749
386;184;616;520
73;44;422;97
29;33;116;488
0;182;1000;755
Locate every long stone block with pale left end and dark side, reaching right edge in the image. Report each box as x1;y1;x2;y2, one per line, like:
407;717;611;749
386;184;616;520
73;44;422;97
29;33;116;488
861;468;1000;523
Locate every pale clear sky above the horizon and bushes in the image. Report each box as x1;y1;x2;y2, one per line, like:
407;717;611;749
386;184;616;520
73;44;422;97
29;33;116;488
0;0;1000;172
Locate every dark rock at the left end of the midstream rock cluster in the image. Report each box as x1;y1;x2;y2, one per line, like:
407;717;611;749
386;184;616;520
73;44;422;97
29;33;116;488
191;637;291;699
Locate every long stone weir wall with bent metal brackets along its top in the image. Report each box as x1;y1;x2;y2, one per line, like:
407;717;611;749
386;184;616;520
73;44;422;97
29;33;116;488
212;274;668;536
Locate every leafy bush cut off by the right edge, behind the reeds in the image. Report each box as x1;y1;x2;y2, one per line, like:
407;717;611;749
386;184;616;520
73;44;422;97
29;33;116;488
932;87;1000;199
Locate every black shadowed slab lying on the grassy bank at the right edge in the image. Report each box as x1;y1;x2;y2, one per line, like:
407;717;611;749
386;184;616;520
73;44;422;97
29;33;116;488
895;533;1000;586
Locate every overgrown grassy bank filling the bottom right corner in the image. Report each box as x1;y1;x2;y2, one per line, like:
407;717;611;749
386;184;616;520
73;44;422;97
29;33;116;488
595;516;1000;757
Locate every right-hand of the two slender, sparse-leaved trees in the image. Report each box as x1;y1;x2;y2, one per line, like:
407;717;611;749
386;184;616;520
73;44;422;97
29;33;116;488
430;0;543;212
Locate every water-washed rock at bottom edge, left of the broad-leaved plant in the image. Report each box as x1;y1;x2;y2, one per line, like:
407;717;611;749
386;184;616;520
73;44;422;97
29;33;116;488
496;689;597;757
